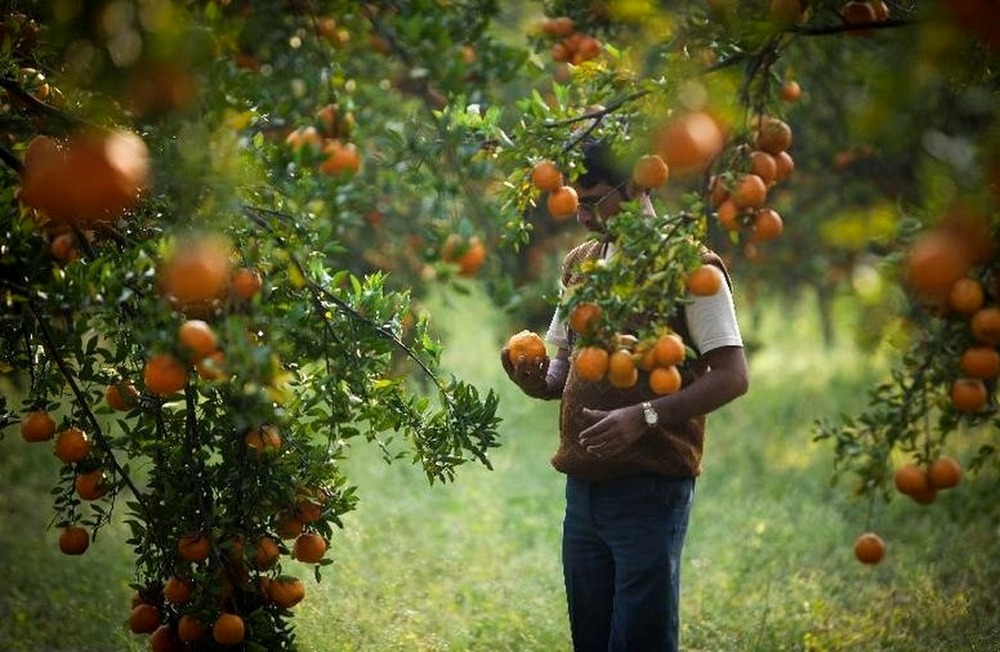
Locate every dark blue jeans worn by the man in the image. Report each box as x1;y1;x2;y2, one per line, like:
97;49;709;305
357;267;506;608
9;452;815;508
563;475;695;652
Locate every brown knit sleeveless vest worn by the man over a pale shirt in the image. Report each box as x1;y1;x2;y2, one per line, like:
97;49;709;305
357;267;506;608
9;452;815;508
552;240;729;481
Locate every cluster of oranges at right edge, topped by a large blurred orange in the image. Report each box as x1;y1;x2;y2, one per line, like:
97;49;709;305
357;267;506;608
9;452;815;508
904;207;1000;413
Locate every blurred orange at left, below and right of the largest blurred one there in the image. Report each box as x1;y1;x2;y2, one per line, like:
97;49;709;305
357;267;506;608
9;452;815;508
156;235;232;308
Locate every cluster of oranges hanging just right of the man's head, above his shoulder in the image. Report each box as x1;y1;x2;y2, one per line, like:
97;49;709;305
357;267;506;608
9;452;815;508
710;116;795;242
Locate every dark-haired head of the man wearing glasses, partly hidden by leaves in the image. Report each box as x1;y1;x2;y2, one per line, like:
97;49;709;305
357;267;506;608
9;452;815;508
573;138;634;233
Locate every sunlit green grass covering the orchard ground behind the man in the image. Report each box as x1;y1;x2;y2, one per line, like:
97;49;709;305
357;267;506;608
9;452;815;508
0;296;1000;652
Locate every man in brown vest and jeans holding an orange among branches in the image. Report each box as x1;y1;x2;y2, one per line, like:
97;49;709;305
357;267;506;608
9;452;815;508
501;141;749;652
